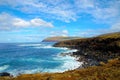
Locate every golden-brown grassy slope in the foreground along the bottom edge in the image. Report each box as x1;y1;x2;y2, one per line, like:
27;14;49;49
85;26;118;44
0;58;120;80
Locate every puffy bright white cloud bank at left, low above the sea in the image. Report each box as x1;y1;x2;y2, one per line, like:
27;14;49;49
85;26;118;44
0;13;54;30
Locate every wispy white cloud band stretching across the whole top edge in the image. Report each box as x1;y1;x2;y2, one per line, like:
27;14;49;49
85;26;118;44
0;0;120;22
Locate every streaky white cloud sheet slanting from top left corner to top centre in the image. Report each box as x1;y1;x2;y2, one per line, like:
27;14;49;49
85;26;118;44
0;0;77;22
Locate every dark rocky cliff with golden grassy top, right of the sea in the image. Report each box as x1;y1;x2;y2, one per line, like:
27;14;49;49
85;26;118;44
54;32;120;61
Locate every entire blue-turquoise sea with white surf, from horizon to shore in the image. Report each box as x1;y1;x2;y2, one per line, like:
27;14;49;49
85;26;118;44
0;42;81;75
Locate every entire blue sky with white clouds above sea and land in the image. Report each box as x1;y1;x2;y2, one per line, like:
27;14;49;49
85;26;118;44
0;0;120;43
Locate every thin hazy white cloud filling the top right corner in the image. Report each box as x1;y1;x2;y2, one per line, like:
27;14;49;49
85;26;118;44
75;0;120;23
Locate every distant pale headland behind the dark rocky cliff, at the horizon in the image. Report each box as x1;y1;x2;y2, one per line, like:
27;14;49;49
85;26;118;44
42;36;80;42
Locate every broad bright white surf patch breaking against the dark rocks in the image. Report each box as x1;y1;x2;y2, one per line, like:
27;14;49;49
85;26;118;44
48;55;83;73
